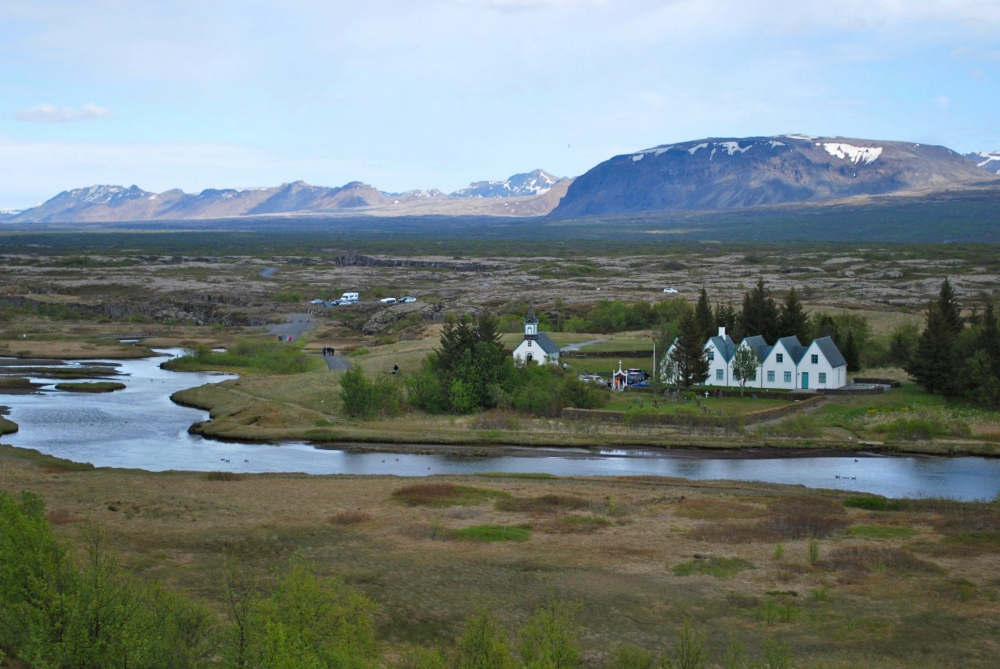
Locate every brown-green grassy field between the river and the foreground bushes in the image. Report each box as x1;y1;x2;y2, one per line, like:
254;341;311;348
0;447;1000;669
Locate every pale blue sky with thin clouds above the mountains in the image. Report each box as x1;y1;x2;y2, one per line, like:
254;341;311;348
0;0;1000;210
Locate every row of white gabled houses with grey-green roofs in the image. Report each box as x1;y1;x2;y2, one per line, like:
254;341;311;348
667;328;847;390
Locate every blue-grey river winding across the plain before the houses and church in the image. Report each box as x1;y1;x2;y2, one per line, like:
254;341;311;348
0;350;1000;500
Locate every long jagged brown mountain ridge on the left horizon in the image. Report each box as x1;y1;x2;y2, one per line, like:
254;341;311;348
10;181;388;223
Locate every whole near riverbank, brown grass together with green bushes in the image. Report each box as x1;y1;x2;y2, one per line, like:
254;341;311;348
0;448;1000;669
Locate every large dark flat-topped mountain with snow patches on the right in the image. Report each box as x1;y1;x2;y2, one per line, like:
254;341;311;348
552;135;990;218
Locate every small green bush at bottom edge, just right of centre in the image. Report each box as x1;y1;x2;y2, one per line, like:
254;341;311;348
518;600;580;669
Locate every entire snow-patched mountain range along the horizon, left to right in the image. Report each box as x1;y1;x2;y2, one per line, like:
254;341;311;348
0;134;1000;224
